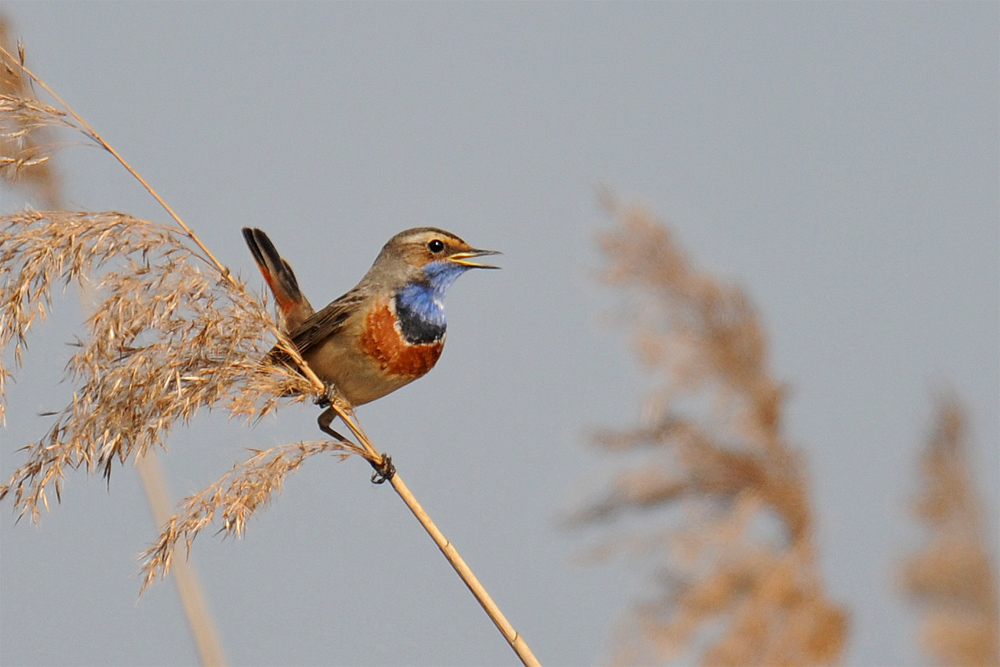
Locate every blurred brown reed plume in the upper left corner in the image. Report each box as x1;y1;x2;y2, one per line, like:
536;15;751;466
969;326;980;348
0;14;61;208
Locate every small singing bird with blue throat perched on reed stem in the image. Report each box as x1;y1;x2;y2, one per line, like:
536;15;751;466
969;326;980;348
243;227;499;440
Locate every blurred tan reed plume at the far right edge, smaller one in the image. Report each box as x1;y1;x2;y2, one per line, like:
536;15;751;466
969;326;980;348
899;397;1000;667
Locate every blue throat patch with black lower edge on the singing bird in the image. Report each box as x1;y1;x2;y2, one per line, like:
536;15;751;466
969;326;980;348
395;261;469;345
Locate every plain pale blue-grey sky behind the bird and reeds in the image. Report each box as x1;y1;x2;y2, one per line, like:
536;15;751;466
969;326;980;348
0;5;1000;665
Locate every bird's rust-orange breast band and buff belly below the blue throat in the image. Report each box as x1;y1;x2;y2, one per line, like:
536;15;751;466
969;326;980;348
305;302;444;406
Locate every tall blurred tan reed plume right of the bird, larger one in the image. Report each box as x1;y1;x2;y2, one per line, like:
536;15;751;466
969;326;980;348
573;197;848;665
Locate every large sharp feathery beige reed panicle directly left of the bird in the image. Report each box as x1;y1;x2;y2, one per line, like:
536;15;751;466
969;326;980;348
0;211;311;520
